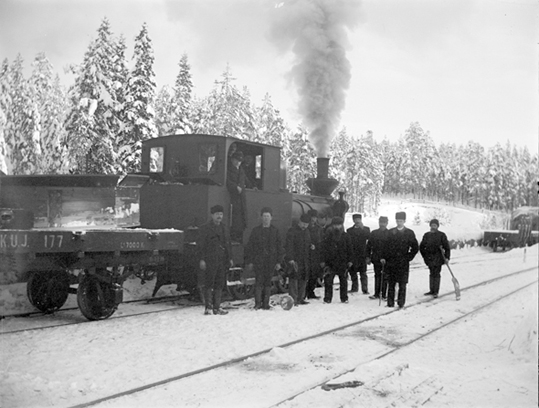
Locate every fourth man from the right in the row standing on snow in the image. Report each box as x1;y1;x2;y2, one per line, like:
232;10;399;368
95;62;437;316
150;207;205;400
346;214;371;295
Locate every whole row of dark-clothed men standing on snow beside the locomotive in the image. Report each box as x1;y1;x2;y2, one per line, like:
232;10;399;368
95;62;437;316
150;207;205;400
197;205;450;315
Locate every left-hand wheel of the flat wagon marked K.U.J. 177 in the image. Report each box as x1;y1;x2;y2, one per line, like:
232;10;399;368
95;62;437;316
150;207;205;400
26;271;69;313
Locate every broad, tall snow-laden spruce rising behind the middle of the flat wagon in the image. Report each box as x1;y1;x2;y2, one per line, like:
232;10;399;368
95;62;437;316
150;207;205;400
66;18;122;174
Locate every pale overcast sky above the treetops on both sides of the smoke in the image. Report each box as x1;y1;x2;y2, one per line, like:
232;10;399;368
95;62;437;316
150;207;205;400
0;0;539;152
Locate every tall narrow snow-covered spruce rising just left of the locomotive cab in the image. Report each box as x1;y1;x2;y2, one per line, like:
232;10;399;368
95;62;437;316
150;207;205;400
119;24;157;173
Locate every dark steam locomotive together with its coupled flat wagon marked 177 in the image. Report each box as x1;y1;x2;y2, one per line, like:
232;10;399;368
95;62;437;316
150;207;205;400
0;134;338;320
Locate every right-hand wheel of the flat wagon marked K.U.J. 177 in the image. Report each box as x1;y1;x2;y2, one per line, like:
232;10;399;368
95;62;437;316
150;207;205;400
77;275;118;320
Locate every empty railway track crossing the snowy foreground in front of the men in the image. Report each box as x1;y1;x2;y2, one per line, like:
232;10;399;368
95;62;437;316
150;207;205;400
64;267;537;408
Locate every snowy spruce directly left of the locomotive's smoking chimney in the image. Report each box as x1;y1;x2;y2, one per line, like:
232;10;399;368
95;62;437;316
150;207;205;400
283;126;316;194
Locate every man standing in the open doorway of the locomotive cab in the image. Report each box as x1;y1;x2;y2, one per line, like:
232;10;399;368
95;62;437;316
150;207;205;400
226;150;247;242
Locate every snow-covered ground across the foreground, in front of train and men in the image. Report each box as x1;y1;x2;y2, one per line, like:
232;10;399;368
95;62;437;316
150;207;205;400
0;246;538;407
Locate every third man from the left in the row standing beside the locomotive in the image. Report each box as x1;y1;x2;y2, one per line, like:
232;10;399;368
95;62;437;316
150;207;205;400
285;214;313;305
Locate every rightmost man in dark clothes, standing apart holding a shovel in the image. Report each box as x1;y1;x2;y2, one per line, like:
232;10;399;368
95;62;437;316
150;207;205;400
419;218;451;298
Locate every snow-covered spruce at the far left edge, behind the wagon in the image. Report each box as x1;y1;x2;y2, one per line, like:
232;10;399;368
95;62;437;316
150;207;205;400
4;54;41;174
